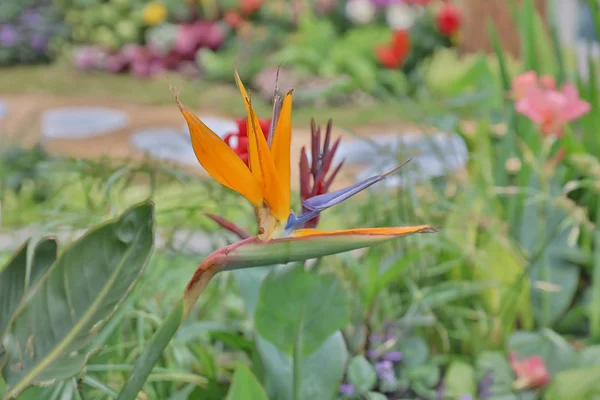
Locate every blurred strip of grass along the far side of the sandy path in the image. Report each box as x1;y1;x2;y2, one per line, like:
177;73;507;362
0;62;450;128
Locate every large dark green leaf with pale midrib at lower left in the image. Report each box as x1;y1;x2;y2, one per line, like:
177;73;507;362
3;202;154;398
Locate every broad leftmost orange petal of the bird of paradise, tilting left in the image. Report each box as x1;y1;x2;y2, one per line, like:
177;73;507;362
175;96;263;207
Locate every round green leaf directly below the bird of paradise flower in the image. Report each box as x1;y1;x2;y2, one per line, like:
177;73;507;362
254;264;349;356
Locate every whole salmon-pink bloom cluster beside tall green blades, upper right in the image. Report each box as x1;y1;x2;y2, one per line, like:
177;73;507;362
512;71;591;137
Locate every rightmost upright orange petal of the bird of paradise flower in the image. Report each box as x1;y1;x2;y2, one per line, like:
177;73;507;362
271;90;292;213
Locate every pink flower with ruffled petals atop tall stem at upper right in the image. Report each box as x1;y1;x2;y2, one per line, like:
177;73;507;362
515;83;591;136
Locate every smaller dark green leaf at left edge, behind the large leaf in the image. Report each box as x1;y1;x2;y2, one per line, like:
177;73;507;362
0;238;57;340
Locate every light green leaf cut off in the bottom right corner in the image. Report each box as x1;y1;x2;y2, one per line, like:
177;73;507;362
544;367;600;400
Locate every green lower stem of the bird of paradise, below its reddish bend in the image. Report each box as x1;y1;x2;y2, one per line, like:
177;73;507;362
117;299;184;400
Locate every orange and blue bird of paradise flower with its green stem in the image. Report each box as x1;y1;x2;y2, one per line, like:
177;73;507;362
118;73;435;400
